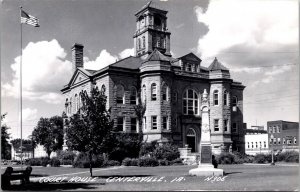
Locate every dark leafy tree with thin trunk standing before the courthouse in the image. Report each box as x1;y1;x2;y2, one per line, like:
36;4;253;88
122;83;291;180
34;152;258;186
66;88;113;177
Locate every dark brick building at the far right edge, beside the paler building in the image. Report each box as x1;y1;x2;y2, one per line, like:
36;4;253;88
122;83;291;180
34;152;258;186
267;120;299;151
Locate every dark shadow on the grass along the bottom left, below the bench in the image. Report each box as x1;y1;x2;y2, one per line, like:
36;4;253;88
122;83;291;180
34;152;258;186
2;182;105;191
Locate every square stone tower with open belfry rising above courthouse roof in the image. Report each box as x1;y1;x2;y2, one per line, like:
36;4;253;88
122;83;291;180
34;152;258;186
133;1;171;58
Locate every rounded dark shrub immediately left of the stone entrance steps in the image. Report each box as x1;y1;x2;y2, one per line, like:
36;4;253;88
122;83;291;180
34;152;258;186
153;143;180;161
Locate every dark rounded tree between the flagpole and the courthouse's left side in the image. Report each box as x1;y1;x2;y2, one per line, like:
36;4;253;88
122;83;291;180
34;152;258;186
32;116;64;158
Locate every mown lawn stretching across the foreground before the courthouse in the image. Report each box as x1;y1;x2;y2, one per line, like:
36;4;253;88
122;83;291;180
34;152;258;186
2;164;299;191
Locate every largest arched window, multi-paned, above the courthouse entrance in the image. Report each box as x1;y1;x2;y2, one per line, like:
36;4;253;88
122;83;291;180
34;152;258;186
183;89;198;115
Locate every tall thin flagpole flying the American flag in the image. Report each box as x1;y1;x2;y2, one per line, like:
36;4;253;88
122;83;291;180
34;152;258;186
20;6;23;169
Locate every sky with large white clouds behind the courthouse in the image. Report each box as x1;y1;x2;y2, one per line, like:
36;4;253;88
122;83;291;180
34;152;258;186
1;0;299;138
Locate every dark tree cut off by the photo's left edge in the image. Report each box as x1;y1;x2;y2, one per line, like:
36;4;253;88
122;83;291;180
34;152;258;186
1;113;11;159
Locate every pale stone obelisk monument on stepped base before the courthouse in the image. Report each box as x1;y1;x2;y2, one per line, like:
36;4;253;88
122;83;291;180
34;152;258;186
189;89;224;176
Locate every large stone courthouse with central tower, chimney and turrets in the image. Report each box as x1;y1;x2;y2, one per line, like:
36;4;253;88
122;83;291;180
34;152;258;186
61;2;245;153
